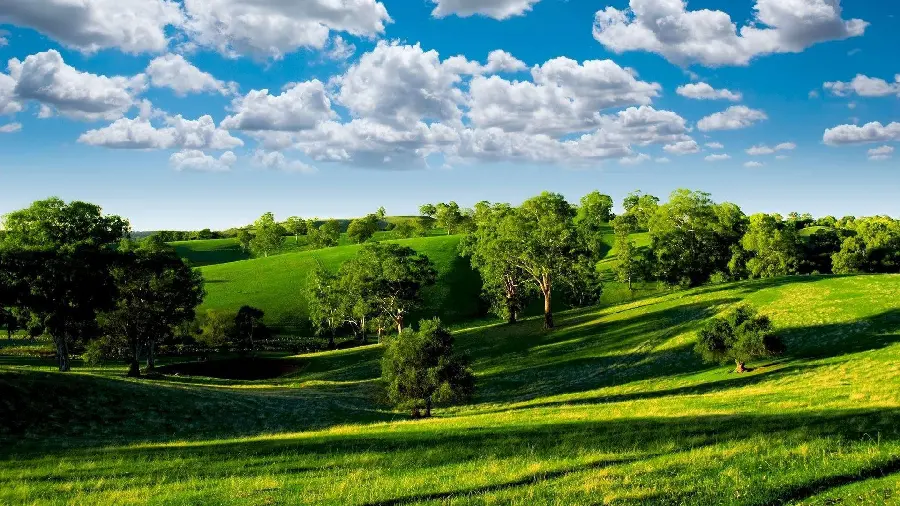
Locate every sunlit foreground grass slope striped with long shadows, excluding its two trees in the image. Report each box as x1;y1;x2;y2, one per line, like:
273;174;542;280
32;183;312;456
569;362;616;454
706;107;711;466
0;276;900;505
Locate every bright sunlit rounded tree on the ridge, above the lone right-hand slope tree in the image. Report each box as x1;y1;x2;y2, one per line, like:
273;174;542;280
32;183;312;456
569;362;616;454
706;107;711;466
742;214;803;278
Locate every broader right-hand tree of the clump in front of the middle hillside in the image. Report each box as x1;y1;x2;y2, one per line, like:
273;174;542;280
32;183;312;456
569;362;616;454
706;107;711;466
352;243;437;333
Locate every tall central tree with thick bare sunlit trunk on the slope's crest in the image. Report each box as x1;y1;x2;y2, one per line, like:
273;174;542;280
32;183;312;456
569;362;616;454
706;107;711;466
510;192;581;329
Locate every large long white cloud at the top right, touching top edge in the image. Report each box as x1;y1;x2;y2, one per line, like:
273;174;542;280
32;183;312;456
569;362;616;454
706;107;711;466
593;0;868;67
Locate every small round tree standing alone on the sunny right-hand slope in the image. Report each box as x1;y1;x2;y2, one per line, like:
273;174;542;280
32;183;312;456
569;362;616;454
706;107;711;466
696;306;785;373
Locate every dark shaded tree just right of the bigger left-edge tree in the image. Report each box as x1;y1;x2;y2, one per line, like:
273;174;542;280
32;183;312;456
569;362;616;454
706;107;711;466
100;248;205;377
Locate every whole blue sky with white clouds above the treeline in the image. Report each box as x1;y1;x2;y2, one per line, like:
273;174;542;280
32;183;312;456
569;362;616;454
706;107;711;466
0;0;900;230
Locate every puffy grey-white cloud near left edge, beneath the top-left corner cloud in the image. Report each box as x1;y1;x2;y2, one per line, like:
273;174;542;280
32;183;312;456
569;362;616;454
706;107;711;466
9;49;146;121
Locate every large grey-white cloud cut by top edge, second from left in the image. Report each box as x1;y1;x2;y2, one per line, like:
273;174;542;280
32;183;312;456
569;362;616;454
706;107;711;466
184;0;391;59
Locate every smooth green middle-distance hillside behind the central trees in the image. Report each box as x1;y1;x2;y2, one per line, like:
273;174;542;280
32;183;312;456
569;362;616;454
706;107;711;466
201;236;481;333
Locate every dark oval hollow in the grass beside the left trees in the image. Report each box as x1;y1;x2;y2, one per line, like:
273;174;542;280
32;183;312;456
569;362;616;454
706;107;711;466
157;358;303;380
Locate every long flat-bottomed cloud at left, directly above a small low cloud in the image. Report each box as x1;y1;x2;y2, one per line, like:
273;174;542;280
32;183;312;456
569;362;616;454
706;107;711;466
78;115;244;150
